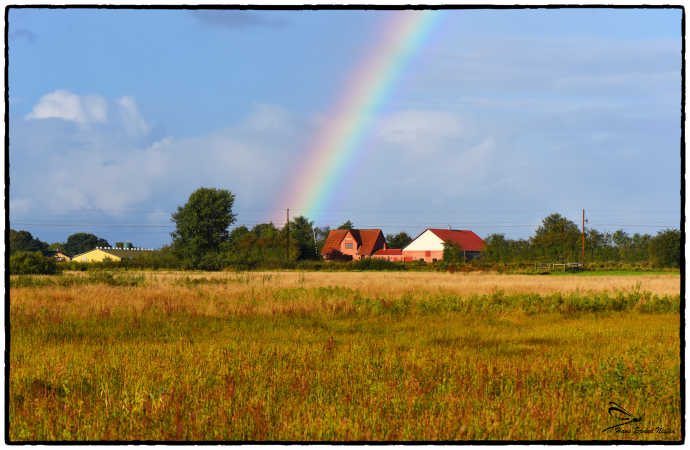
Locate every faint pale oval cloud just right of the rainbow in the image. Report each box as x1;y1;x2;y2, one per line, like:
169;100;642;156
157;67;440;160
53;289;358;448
376;110;464;151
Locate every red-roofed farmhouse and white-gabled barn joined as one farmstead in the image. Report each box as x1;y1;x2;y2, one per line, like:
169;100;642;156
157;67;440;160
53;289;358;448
321;228;484;262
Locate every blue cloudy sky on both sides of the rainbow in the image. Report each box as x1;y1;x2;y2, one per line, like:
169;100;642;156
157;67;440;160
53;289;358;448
9;9;681;247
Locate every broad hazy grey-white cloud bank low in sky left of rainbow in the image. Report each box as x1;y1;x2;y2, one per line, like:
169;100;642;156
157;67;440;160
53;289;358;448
12;102;296;223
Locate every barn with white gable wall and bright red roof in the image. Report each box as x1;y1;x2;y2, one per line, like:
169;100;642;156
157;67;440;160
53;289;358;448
402;228;484;262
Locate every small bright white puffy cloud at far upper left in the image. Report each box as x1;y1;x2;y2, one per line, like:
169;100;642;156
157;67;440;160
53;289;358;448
26;90;108;124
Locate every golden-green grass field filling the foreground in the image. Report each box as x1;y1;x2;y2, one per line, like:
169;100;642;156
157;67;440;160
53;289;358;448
9;272;681;441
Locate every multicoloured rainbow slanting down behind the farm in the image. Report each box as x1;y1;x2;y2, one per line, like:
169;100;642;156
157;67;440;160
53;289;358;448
274;10;438;222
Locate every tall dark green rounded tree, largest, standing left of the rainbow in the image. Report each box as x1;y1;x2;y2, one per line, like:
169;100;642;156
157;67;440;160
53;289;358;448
171;188;236;267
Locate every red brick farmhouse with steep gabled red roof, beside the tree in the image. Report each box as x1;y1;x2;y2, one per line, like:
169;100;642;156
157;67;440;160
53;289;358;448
321;229;386;261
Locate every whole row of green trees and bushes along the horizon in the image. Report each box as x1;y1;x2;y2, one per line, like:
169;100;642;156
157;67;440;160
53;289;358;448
9;188;681;270
